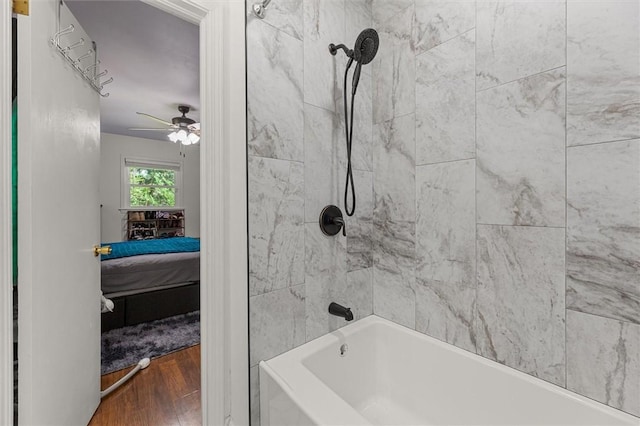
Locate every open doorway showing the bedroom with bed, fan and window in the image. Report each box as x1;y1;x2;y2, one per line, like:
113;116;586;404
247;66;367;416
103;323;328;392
60;0;200;424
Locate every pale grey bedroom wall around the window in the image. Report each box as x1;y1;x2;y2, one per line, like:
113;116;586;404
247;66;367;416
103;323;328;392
100;133;200;242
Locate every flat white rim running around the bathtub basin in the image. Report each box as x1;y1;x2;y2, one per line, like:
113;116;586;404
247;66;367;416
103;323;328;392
259;314;640;425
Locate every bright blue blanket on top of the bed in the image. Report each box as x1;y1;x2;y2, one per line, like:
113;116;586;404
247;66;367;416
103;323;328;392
100;237;200;260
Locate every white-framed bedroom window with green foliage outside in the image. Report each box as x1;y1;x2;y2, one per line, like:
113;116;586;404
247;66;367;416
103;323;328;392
122;158;182;208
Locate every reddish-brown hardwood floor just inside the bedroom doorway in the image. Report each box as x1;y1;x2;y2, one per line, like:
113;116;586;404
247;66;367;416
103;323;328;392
89;345;202;426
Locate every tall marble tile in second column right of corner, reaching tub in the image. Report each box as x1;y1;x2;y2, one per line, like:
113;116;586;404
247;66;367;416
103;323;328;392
416;160;476;351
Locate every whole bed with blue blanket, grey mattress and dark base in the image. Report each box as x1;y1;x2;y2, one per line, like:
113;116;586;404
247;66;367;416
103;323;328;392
101;237;200;332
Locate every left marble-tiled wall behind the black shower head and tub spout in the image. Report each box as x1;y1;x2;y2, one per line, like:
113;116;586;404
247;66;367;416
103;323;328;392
247;0;373;425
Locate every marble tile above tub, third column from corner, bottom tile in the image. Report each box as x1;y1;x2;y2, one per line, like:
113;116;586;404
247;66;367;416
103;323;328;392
475;225;565;386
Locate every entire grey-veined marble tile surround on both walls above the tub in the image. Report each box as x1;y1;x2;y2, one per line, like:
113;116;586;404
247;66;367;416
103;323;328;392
247;0;640;424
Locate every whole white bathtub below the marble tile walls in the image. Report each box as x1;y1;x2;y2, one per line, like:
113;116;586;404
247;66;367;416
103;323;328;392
260;315;640;426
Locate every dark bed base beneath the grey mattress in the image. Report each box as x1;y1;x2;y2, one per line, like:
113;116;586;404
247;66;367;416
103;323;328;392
101;281;200;333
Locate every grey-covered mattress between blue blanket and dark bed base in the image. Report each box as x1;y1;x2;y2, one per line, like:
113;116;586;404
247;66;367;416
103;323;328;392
101;252;200;296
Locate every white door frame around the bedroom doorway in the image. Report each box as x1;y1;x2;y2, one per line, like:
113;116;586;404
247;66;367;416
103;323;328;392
0;0;249;425
